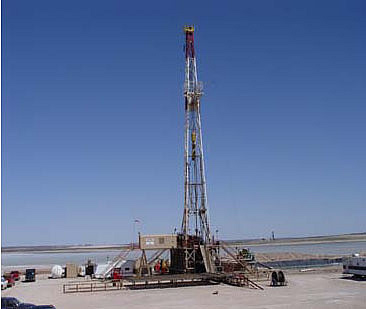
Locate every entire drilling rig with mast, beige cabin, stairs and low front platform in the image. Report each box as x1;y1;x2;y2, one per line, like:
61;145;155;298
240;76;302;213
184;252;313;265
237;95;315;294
81;26;277;289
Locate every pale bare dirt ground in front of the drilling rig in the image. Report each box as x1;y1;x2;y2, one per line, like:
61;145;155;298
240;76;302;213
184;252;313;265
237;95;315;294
2;271;366;309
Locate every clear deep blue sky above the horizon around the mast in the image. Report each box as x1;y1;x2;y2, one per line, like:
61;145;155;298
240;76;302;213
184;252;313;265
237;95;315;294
2;0;366;246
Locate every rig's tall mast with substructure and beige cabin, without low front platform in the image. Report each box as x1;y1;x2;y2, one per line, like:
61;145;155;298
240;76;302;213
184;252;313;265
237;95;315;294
105;26;219;275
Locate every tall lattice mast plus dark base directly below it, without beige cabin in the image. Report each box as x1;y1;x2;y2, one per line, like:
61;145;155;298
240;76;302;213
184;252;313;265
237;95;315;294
172;26;212;272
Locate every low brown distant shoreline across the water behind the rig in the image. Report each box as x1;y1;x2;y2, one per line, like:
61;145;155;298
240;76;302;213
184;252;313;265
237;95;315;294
1;233;366;253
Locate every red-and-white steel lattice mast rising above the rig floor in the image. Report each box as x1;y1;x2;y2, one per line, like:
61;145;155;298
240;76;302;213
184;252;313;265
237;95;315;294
182;26;211;244
